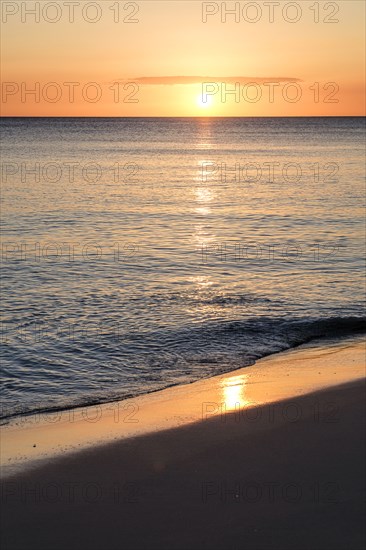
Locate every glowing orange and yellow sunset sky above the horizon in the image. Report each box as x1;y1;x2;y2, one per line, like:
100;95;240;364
1;0;365;116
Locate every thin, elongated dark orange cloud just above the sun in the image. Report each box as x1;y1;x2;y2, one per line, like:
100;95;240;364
115;76;303;86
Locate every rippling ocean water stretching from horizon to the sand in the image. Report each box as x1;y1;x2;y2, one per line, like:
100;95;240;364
1;117;365;419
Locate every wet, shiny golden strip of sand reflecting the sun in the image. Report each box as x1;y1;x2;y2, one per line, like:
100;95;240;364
1;336;365;477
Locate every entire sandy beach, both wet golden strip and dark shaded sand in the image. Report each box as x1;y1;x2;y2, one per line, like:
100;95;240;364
2;338;365;550
